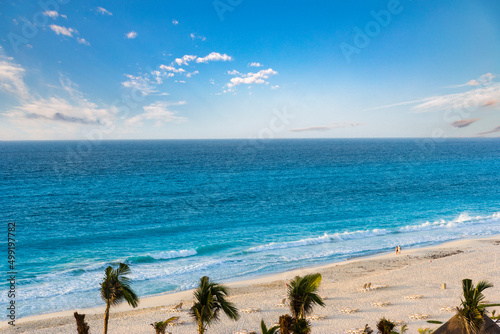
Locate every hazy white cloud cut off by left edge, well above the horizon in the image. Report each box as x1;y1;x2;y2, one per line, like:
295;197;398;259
0;47;28;98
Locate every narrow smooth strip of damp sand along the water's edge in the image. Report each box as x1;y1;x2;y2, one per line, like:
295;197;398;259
4;235;500;329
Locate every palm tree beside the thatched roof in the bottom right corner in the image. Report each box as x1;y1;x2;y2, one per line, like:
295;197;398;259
457;278;500;334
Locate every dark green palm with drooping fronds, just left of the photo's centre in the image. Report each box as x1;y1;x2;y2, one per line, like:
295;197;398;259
190;276;240;334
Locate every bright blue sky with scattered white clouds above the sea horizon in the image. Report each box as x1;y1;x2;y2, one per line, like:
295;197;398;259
0;0;500;140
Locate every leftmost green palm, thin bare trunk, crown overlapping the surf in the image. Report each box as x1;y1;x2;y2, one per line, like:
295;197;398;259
100;263;139;334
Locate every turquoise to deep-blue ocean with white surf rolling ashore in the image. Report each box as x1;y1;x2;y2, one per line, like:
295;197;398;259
0;139;500;316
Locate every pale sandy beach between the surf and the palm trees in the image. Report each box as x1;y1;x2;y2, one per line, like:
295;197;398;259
0;236;500;334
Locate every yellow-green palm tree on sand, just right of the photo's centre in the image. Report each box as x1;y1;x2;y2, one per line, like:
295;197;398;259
288;273;325;321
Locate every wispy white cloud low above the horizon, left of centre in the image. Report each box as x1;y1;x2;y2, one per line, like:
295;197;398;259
125;101;186;126
